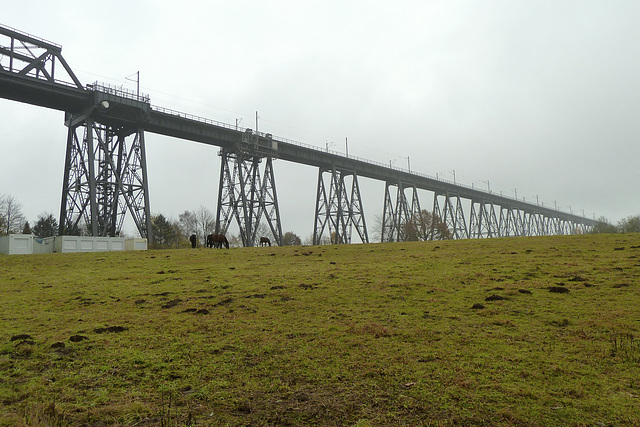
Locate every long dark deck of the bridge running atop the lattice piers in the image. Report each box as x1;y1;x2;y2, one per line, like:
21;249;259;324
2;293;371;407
0;69;597;225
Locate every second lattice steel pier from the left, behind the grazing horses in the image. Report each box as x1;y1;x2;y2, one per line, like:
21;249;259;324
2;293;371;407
216;148;282;247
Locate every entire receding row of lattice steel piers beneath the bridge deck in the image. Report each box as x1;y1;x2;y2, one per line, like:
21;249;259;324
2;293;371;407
60;113;590;246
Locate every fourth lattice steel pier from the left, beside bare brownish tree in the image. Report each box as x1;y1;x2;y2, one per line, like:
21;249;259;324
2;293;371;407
380;181;422;242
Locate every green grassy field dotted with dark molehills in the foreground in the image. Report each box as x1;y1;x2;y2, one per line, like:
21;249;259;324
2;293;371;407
0;234;640;427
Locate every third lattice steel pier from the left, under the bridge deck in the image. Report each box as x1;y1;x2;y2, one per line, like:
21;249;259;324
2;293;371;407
313;167;369;245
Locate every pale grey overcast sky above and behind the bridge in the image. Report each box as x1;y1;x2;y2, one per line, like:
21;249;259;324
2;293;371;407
0;0;640;239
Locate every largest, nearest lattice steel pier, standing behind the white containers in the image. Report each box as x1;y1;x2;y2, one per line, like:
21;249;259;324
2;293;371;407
59;114;151;241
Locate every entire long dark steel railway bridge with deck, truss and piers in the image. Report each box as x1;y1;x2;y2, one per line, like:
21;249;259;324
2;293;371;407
0;26;597;246
